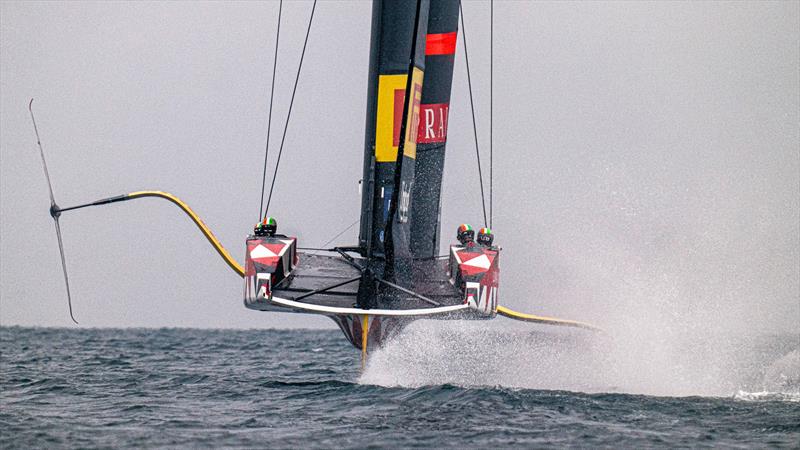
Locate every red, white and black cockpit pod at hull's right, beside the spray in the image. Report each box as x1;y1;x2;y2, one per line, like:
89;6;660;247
447;241;500;318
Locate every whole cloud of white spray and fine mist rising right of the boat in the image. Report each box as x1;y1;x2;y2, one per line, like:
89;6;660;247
361;172;800;401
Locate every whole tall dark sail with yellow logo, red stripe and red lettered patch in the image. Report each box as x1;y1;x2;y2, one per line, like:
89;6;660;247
359;0;458;306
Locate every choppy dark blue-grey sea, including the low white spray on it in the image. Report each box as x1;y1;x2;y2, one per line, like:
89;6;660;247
0;322;800;449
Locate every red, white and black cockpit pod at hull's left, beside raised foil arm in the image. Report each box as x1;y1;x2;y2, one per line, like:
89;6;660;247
244;235;299;304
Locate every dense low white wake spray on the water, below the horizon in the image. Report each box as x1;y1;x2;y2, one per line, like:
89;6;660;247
359;320;800;401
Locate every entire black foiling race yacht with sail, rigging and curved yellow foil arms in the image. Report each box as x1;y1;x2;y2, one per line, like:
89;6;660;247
29;0;594;357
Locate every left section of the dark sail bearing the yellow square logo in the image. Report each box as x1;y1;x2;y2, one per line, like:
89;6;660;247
359;0;429;264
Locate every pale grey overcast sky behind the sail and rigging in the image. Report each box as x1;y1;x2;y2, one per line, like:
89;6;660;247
0;1;800;331
